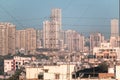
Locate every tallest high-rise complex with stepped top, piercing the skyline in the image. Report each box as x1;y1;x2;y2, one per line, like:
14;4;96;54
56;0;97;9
43;9;61;49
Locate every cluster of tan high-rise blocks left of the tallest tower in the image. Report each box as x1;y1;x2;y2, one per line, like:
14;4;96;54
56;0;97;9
0;23;36;55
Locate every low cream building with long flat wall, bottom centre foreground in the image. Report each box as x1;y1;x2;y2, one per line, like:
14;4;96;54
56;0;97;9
26;64;75;80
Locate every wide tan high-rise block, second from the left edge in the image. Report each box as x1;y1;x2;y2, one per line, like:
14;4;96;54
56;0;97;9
16;28;36;52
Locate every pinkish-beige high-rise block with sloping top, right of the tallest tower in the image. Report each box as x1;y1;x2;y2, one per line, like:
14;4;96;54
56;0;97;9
65;30;85;52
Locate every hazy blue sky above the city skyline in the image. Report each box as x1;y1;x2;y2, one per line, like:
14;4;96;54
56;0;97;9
0;0;119;37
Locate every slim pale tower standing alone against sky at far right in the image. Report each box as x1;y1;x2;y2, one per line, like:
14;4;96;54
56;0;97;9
111;19;119;37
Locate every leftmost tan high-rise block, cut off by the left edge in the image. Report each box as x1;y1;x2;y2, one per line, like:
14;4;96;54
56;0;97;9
0;23;16;55
